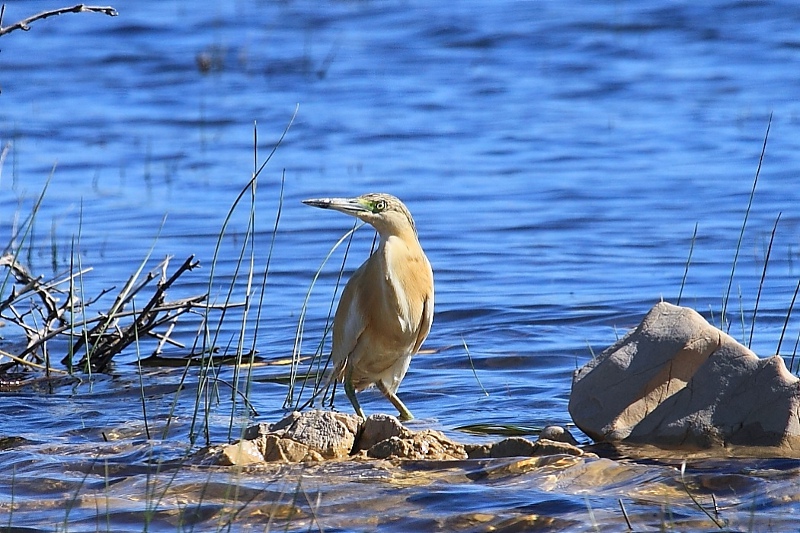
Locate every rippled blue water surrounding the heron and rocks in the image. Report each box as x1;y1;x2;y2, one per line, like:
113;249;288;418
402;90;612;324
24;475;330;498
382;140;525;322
0;0;800;531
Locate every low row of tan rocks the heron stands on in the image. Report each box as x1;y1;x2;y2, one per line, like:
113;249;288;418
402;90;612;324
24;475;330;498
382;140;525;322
203;410;584;465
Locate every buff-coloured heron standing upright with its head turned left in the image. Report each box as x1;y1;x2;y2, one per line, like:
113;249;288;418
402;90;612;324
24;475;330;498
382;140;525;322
303;193;433;420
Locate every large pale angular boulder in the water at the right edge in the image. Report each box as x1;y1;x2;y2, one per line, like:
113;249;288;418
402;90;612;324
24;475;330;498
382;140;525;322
569;302;800;451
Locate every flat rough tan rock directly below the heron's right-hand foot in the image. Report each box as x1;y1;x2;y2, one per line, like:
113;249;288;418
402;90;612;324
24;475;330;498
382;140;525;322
367;429;467;461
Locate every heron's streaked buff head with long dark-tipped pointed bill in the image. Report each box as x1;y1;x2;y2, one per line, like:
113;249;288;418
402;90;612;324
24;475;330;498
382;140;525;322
303;193;417;238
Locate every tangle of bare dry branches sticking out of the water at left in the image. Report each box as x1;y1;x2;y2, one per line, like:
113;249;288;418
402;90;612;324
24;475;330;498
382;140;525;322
0;254;240;376
